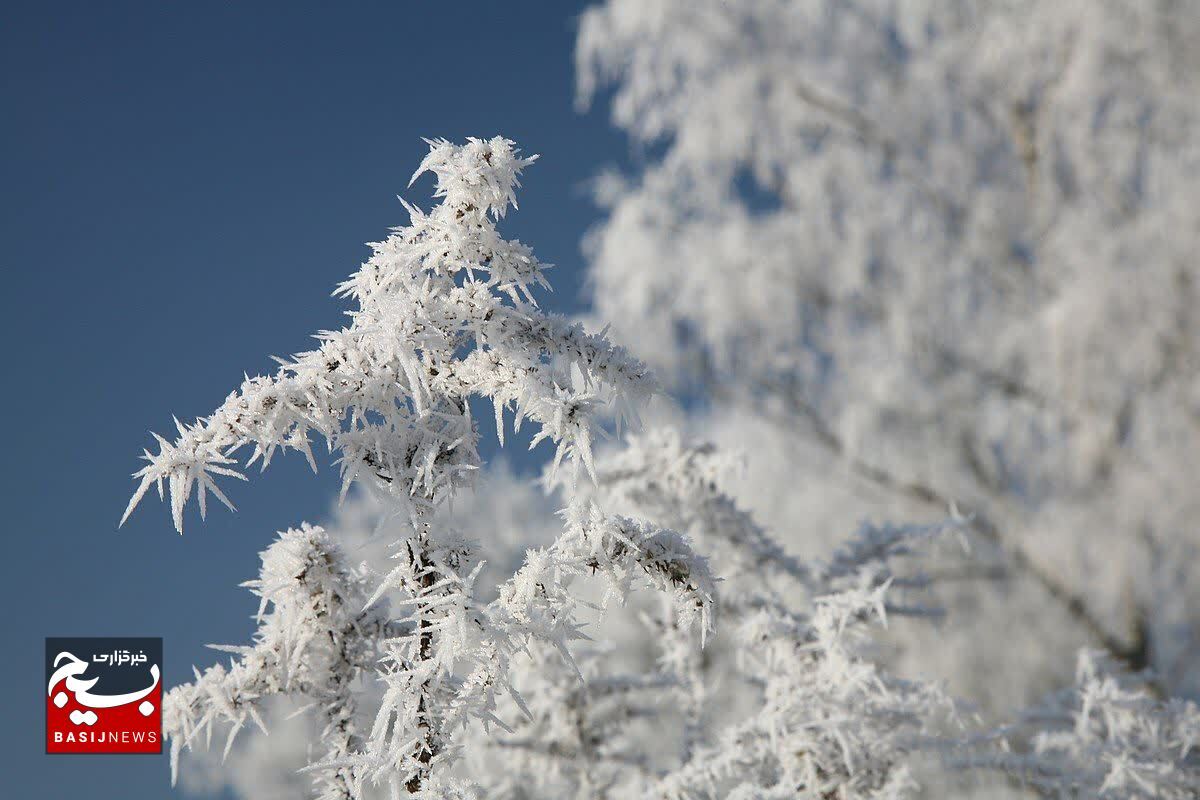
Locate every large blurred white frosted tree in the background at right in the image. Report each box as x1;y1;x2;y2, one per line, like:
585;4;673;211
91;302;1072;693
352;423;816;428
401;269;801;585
577;0;1200;704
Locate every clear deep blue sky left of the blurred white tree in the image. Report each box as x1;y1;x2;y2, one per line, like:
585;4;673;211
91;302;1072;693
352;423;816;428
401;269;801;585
0;1;626;800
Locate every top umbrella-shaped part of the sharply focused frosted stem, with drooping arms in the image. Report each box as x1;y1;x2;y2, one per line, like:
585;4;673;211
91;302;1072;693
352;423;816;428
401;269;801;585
125;138;654;531
